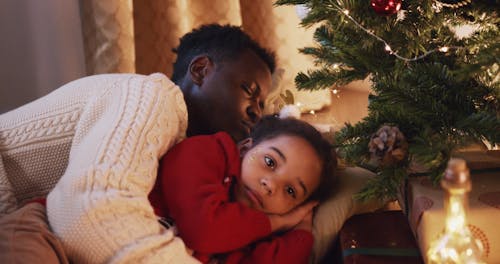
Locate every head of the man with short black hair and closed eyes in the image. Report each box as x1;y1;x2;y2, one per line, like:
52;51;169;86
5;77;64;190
172;25;275;141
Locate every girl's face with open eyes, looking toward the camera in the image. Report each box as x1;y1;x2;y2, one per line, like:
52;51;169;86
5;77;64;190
235;135;321;214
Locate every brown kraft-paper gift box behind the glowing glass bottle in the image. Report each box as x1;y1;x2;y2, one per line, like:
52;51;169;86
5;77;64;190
399;151;500;263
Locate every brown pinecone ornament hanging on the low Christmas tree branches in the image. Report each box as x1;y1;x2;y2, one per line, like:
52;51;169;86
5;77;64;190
368;125;408;166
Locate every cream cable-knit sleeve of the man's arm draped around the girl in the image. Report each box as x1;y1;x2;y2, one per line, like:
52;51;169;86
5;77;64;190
47;74;197;263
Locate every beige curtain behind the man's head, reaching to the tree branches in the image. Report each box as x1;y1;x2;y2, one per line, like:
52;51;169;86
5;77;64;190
80;0;331;112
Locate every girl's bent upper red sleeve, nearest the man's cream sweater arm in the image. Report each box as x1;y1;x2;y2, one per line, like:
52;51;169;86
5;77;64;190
160;132;271;254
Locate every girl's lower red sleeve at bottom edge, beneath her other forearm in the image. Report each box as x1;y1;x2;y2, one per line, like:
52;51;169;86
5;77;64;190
224;230;314;264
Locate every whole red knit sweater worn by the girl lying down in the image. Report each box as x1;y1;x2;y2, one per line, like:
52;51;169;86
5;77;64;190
149;132;313;263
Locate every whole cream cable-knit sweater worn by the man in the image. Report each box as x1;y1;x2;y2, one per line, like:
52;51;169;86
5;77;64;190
0;74;201;263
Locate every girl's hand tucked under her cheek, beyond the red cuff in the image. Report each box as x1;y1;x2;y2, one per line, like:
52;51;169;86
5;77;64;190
268;201;318;232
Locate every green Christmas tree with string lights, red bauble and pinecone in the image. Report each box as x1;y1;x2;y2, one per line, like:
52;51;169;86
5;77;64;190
277;0;500;199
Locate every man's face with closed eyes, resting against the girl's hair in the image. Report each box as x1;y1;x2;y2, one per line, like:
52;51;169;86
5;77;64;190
197;51;271;141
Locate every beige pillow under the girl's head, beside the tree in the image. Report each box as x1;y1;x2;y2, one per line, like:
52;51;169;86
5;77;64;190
311;167;385;263
